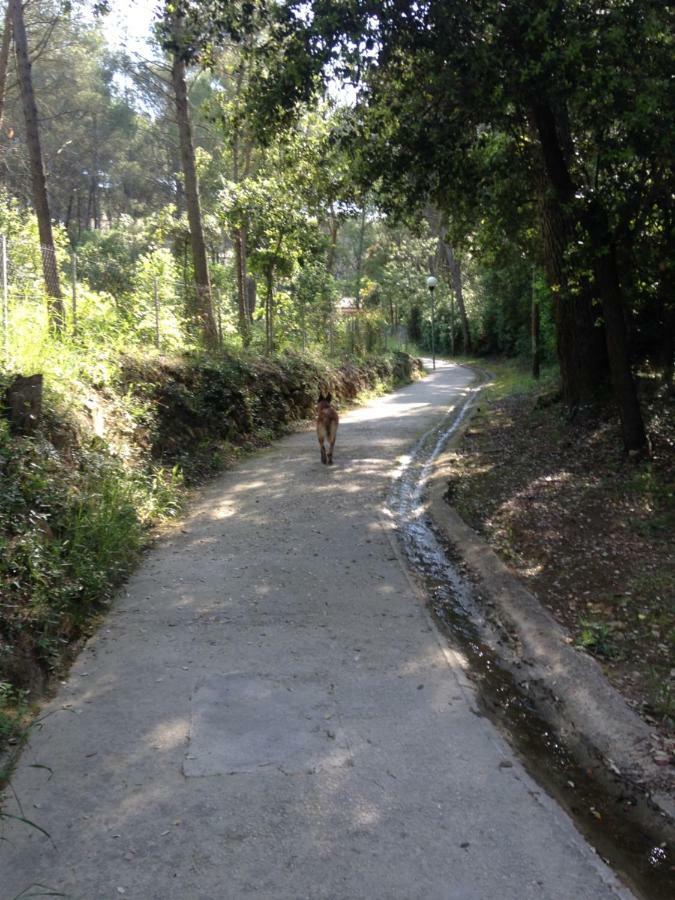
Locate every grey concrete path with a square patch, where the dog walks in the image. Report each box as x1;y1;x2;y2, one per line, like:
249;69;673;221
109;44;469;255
0;366;630;900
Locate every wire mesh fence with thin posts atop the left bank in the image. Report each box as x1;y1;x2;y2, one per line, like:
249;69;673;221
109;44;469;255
0;235;407;368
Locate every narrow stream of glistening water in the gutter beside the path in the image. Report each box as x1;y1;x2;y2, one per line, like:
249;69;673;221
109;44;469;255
387;394;675;900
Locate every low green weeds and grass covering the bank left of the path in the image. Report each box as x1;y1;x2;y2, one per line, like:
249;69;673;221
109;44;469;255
0;424;180;677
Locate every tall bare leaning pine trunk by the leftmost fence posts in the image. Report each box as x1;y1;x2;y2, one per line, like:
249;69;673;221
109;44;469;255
10;0;66;333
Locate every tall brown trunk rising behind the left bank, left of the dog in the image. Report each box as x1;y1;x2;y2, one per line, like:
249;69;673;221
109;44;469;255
171;41;218;348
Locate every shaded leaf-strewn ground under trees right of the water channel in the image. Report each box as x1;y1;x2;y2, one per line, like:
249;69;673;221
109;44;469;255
448;362;675;767
